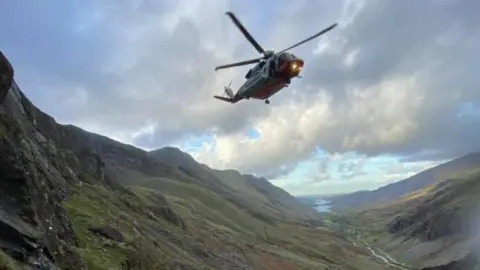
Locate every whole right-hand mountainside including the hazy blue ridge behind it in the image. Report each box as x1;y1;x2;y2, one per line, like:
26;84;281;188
332;153;480;270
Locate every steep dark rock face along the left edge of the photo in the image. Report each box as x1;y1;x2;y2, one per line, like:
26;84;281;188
0;57;89;269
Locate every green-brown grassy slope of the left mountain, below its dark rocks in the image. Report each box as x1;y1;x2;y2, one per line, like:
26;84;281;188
65;174;394;269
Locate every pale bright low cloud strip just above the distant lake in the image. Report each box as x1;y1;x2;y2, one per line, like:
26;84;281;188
272;152;445;195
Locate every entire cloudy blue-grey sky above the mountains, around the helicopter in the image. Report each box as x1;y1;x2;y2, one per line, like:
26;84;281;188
0;0;480;195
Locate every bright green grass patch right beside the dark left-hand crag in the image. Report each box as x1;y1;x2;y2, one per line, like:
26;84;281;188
64;184;195;269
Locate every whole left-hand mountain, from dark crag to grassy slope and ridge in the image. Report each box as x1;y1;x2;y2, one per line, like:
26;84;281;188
0;51;389;270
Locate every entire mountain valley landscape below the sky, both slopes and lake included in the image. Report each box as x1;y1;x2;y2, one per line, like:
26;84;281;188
0;51;480;270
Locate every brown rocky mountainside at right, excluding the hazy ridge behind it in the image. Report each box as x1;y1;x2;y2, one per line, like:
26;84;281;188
344;171;480;270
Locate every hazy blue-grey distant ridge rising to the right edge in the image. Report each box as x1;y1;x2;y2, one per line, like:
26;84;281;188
330;153;480;208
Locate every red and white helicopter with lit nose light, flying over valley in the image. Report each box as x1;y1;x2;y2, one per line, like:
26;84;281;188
213;12;337;104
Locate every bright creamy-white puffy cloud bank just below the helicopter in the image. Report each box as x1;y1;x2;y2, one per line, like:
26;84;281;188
193;74;422;175
